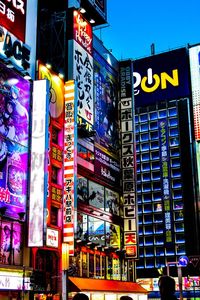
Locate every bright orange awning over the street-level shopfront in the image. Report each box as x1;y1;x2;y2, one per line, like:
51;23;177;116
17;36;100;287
68;277;148;294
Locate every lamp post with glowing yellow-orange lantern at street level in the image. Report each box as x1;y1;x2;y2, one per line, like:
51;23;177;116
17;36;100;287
62;243;69;300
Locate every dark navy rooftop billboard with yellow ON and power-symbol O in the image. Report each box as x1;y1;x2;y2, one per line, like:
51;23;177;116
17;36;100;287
133;48;190;107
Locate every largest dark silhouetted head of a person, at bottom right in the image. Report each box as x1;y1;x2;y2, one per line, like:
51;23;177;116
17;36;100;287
158;275;177;300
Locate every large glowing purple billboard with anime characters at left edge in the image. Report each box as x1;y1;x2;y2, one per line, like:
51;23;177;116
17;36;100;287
0;63;30;220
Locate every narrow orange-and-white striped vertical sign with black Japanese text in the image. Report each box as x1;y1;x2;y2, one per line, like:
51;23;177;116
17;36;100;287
63;80;77;255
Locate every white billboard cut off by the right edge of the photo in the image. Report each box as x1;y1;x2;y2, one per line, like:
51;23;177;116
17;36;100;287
189;45;200;141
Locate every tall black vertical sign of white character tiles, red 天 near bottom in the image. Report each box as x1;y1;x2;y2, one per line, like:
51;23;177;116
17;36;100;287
120;61;138;258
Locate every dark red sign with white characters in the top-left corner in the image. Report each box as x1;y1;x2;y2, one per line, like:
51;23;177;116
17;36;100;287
0;0;27;42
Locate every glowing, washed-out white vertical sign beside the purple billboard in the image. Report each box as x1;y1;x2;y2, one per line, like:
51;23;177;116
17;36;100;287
28;80;48;247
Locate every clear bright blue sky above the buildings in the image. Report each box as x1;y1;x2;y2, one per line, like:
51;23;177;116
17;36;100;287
94;0;200;60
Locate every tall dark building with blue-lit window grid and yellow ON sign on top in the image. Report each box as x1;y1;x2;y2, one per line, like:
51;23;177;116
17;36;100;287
133;48;199;278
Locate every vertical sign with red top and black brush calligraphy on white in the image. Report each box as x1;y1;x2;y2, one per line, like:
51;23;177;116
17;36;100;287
73;11;94;125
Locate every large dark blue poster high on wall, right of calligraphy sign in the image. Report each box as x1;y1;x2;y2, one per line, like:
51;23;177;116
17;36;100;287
94;51;118;148
